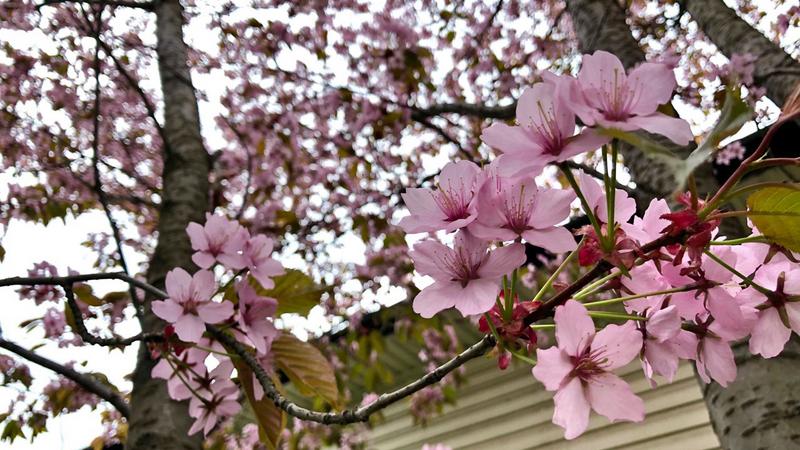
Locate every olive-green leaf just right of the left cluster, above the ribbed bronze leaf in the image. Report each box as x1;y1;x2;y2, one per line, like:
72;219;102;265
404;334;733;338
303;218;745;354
255;269;330;316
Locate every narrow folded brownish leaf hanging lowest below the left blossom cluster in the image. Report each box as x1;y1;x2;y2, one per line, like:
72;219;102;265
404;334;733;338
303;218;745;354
231;358;286;450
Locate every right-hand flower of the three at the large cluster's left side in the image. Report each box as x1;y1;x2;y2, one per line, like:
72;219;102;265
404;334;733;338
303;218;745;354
468;174;577;253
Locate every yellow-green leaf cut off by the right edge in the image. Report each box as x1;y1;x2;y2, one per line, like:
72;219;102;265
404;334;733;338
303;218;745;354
747;187;800;252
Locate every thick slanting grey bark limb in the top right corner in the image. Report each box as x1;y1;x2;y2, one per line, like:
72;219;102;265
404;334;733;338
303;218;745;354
681;0;800;106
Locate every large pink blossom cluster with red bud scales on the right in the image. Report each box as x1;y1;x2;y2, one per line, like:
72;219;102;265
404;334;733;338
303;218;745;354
400;52;800;439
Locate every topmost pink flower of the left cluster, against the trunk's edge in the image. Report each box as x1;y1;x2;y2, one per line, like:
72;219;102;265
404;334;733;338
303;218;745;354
186;214;249;270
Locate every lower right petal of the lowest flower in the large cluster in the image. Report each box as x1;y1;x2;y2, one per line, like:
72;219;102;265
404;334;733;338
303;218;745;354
586;372;644;422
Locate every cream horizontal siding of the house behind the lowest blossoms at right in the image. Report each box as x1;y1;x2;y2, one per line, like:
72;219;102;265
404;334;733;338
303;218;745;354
370;359;719;450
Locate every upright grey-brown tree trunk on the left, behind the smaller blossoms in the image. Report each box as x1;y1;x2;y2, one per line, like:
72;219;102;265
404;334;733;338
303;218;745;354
126;0;210;450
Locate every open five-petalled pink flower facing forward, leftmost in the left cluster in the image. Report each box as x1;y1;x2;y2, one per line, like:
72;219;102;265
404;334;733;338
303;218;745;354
153;267;233;342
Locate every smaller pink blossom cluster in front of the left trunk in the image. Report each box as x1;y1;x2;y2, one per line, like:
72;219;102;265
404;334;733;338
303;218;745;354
152;214;284;435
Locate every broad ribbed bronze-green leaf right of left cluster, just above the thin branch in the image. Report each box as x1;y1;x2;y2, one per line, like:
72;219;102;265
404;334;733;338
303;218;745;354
272;332;339;406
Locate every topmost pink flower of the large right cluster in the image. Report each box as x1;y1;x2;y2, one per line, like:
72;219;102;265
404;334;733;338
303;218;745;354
562;50;693;145
